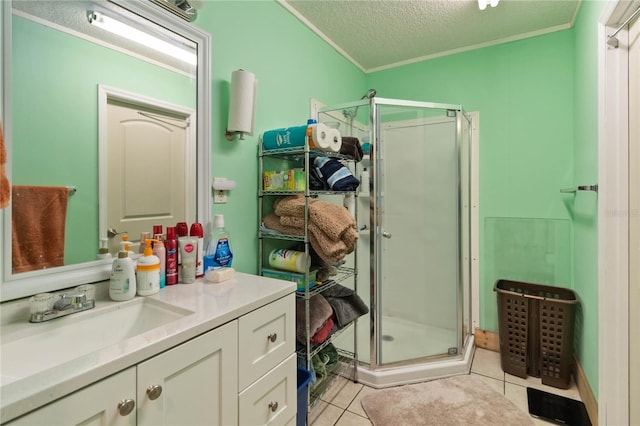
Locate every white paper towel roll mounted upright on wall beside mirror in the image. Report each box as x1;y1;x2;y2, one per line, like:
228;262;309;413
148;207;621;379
227;69;258;135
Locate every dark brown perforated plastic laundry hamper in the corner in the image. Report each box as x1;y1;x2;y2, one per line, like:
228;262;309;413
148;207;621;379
494;280;578;389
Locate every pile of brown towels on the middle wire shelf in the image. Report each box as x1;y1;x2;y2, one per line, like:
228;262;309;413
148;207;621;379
262;195;358;265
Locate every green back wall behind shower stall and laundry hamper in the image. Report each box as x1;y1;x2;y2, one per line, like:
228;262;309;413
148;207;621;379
367;31;574;331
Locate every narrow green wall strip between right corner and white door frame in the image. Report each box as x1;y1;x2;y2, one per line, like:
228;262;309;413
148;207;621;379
569;1;606;397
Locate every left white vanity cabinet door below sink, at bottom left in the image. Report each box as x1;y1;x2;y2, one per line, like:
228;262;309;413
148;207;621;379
7;367;136;426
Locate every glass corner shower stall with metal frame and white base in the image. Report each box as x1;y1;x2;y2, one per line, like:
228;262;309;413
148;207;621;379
318;97;473;387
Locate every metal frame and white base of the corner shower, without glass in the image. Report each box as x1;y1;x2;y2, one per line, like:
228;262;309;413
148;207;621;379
318;97;474;387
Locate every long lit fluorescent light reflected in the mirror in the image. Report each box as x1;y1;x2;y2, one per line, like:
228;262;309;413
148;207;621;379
87;11;198;65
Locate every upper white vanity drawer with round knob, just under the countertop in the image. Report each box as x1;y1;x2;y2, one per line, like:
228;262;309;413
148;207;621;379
238;294;296;390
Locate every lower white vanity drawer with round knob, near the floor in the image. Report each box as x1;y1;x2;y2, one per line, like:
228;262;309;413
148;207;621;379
238;354;298;425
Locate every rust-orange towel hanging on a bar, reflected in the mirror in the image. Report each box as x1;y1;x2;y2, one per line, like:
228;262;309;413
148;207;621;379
11;185;69;274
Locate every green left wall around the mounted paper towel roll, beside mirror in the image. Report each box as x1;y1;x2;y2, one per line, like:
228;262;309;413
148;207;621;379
195;1;365;273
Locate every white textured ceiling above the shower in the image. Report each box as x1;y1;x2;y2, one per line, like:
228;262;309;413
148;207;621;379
278;0;580;72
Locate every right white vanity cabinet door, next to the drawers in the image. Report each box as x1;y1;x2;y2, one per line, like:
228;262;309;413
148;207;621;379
137;321;238;426
